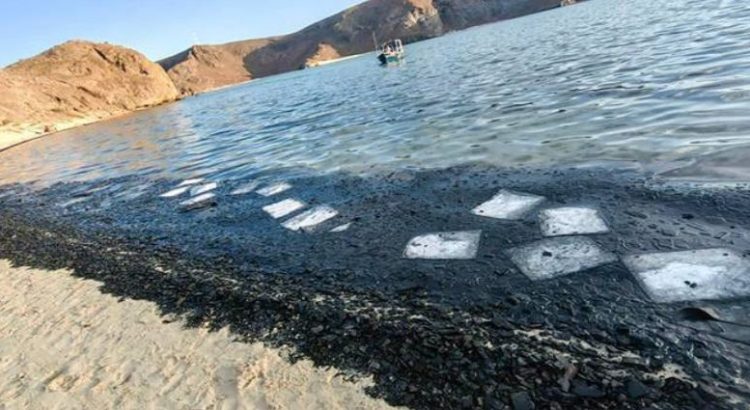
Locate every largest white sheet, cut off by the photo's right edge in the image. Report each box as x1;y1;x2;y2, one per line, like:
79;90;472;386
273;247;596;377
623;249;750;303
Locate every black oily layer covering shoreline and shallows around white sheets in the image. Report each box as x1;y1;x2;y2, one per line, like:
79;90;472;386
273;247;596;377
0;167;750;409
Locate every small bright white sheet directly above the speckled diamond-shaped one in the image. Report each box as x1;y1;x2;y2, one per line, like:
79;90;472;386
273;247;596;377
539;207;609;236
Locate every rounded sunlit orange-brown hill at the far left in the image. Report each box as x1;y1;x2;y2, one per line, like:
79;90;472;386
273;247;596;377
0;41;179;149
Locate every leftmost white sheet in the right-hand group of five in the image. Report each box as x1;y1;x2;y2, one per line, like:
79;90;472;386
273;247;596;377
404;231;482;259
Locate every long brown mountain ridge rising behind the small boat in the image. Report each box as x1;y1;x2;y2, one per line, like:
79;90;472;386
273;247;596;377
159;0;560;94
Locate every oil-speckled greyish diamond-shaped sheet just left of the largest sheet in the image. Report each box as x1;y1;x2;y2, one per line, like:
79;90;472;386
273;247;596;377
507;236;617;281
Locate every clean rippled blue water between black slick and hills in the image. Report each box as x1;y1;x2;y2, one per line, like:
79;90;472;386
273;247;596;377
0;0;750;185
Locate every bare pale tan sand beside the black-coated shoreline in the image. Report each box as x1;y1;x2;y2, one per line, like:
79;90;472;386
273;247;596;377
0;261;400;409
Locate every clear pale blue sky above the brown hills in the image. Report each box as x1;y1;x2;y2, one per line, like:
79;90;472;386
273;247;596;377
0;0;362;67
